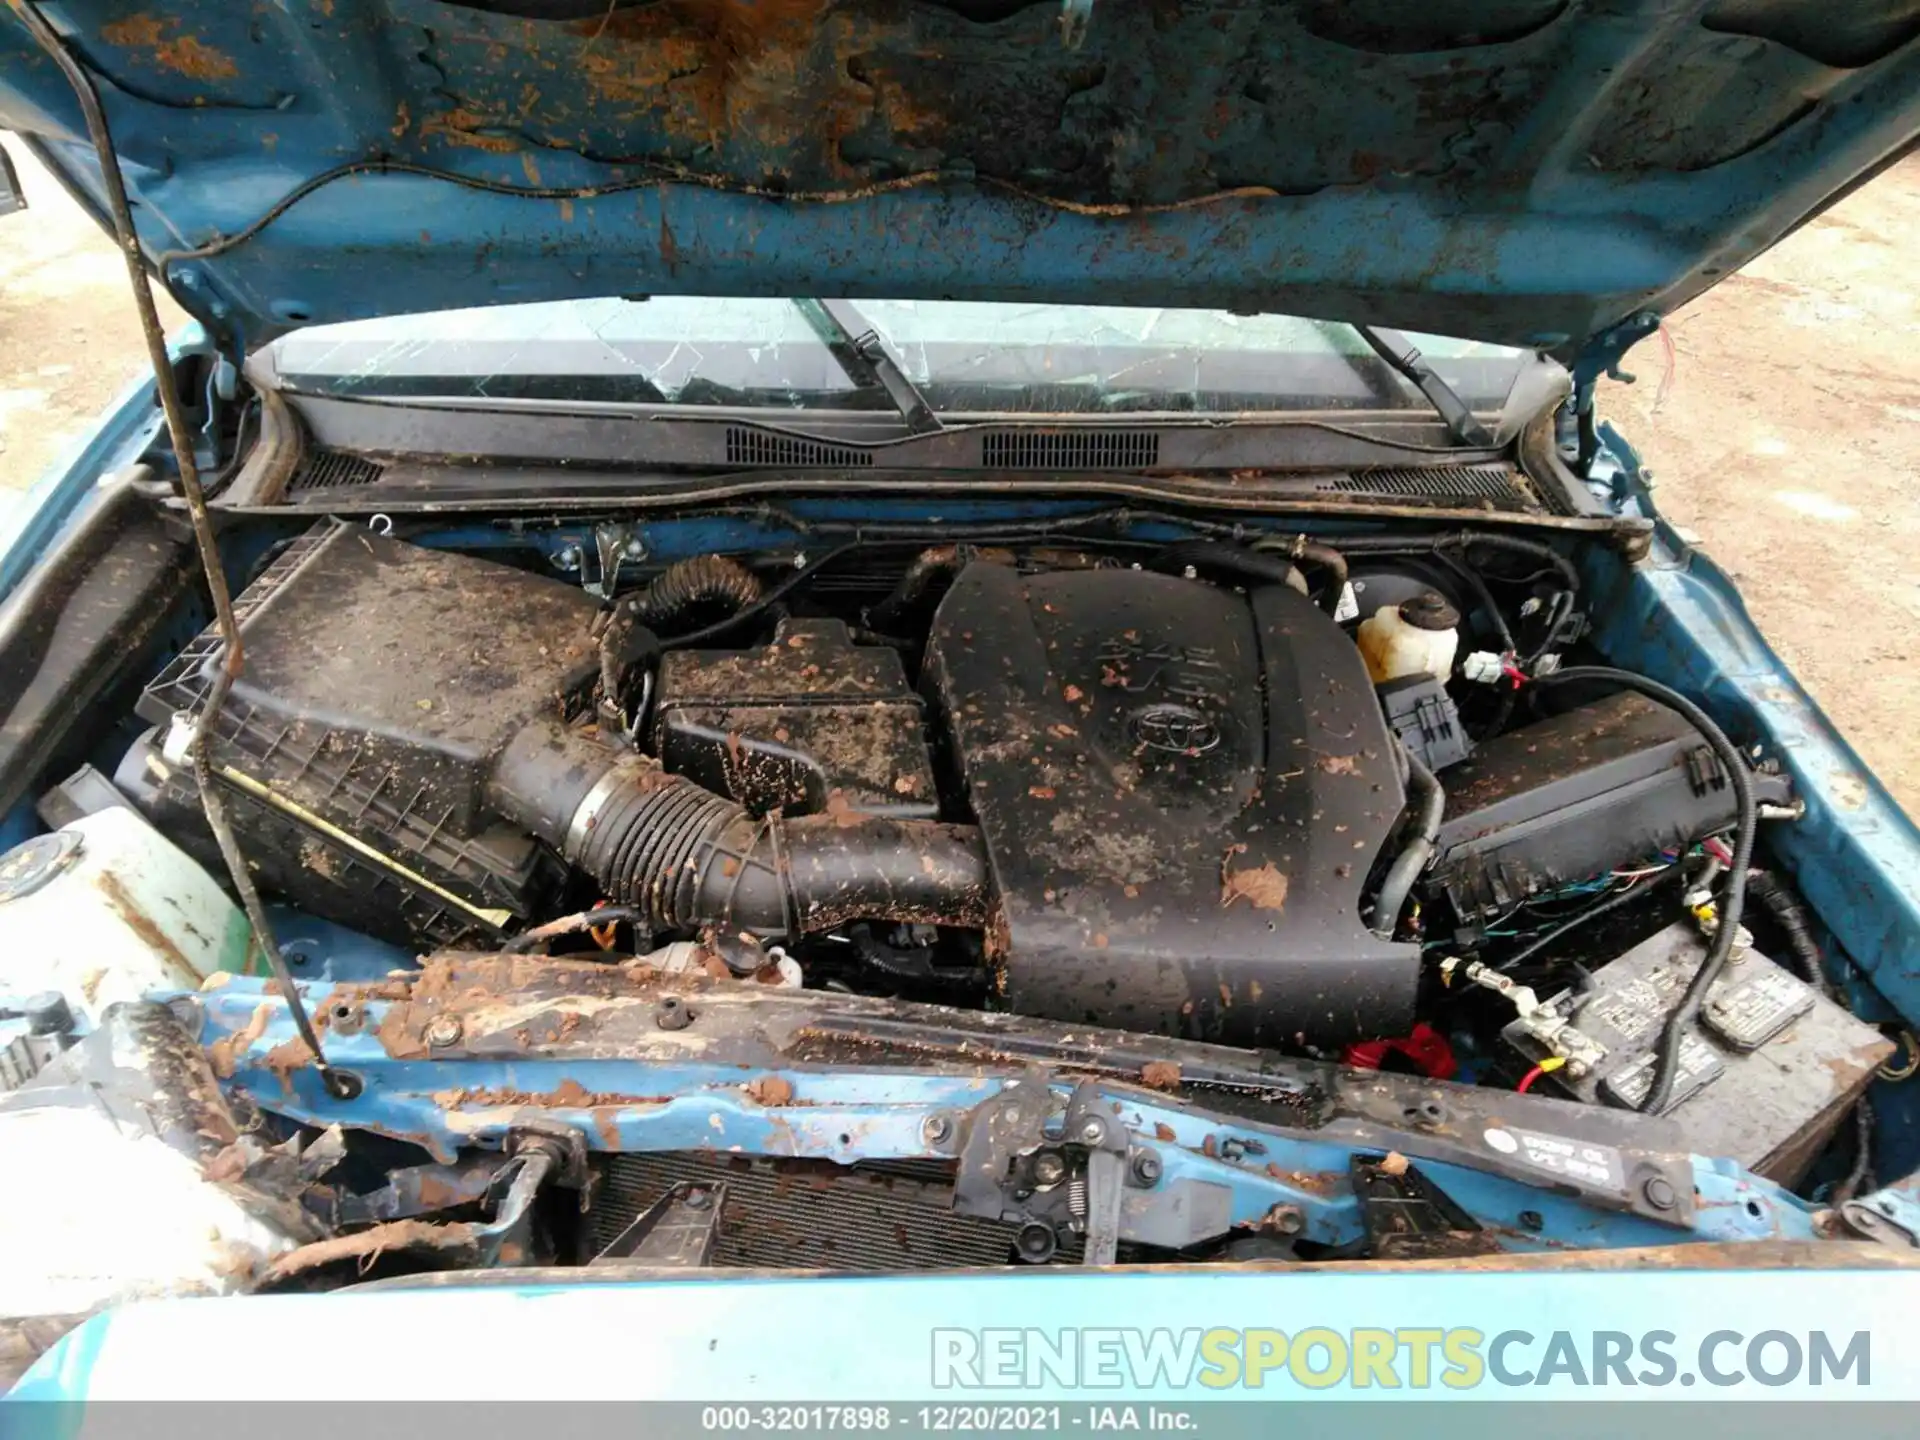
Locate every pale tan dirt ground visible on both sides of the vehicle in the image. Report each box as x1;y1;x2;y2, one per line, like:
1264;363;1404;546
0;138;1920;814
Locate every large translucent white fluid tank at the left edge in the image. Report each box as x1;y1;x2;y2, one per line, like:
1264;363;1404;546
0;808;252;1023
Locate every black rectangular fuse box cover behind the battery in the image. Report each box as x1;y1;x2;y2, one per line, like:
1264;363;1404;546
1434;691;1791;924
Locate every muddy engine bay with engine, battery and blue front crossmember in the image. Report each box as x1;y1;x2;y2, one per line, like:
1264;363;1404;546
0;520;1897;1288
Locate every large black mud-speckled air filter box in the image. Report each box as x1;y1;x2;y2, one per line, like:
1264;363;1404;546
129;526;599;945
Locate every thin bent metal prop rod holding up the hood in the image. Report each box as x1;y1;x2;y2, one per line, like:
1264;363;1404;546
6;0;361;1100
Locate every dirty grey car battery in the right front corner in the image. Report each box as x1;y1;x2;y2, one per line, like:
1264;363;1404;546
1501;924;1893;1185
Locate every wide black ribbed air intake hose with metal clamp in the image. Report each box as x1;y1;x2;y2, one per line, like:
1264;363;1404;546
488;720;989;937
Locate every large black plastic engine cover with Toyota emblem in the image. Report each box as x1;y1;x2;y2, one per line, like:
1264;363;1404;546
927;564;1419;1044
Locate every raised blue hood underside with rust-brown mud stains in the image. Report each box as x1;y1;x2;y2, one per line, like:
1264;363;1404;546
0;0;1920;372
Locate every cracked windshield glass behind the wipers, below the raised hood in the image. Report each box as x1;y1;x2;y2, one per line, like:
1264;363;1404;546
275;296;1532;415
